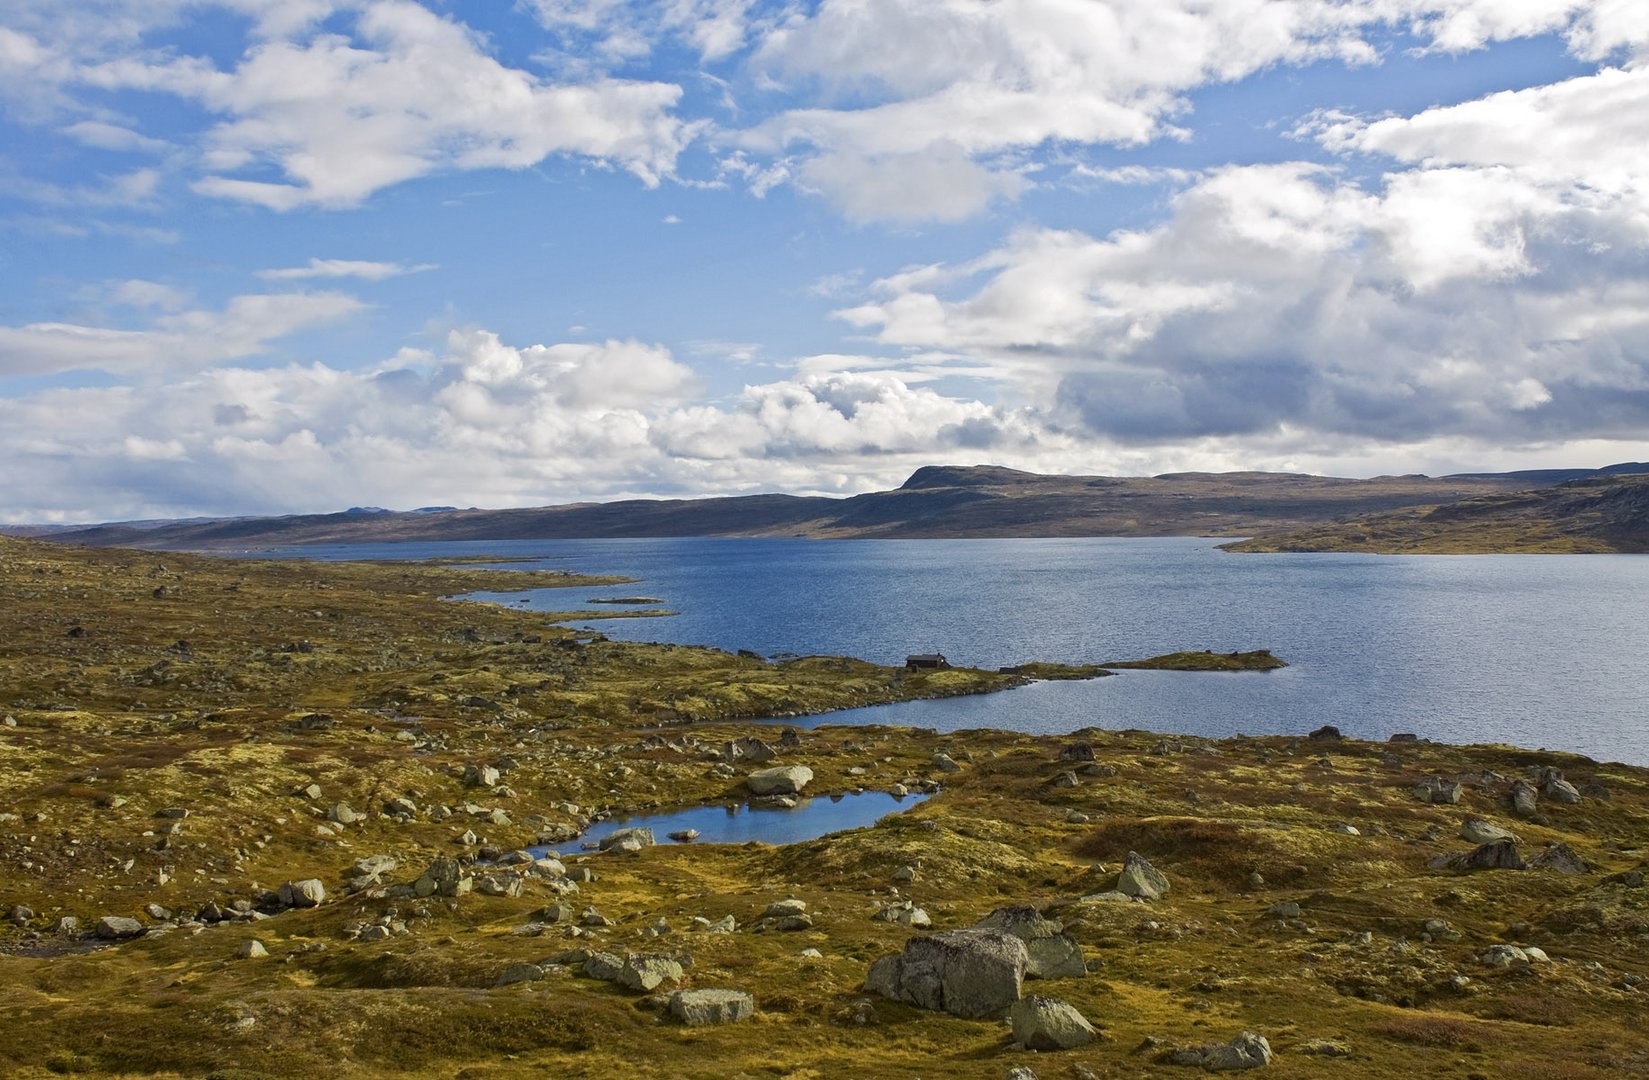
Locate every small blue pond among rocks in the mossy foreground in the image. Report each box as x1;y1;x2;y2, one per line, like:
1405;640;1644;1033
528;791;928;854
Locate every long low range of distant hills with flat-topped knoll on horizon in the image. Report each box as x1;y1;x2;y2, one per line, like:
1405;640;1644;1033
19;463;1649;549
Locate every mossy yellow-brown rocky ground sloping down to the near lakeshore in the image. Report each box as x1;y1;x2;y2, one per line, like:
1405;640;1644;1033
0;541;1649;1080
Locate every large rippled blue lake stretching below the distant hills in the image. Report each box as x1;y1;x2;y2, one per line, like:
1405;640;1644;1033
263;538;1649;763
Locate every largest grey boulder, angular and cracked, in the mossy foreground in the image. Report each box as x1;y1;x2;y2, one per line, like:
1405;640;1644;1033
864;930;1029;1019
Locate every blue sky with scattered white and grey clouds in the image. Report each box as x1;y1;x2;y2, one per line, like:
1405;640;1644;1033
0;0;1649;523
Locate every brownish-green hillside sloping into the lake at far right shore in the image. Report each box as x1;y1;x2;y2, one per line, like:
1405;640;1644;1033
1229;473;1649;554
